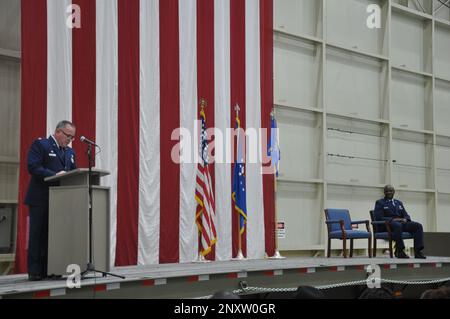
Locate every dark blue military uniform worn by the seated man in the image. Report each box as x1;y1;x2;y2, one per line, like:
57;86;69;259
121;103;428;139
374;198;424;254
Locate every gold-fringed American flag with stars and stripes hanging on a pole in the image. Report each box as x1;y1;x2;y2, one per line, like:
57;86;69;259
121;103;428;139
195;101;217;257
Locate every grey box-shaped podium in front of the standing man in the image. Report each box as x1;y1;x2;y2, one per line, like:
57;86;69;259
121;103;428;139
45;168;110;275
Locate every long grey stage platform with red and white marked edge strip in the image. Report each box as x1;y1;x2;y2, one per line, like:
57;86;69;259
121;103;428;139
0;256;450;299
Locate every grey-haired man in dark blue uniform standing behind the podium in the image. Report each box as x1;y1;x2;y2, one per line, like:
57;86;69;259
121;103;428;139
25;121;76;281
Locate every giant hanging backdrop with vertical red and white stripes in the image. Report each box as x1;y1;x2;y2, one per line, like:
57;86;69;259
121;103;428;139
16;0;275;273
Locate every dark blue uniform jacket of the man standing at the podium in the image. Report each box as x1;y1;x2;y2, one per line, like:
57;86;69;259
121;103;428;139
25;136;76;206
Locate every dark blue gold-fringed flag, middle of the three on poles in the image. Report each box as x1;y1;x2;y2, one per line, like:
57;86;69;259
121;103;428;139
231;117;247;235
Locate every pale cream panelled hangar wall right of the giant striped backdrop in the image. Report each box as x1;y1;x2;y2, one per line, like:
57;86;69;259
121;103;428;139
274;0;450;255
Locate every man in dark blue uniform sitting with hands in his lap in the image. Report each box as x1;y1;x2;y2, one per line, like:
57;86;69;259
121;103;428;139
374;185;426;259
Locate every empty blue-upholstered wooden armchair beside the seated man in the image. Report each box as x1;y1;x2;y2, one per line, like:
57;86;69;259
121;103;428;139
325;208;372;258
